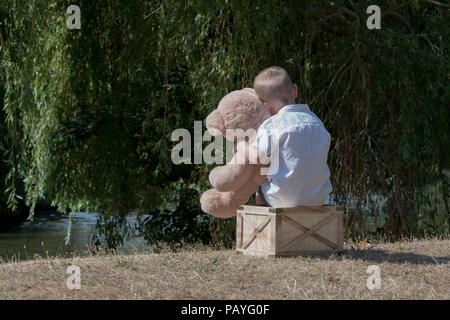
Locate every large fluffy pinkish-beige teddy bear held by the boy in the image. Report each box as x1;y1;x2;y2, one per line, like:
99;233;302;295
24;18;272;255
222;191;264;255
200;88;270;218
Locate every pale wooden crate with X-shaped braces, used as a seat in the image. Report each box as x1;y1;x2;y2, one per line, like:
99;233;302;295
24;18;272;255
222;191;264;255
236;206;344;256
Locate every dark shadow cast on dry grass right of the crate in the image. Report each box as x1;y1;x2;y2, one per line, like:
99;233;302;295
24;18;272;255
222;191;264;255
340;249;450;265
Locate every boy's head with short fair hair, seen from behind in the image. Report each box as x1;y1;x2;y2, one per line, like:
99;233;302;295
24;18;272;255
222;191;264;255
253;66;298;115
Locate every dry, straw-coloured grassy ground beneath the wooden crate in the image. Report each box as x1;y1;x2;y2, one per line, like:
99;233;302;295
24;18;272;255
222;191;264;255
0;240;450;299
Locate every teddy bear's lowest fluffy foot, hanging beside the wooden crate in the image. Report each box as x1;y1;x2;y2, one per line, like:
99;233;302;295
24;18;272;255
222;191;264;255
200;189;237;218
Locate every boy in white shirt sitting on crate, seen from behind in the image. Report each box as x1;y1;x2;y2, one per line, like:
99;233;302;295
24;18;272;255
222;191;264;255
237;67;332;207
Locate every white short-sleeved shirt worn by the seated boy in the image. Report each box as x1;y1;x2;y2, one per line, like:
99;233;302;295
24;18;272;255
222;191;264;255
253;104;332;207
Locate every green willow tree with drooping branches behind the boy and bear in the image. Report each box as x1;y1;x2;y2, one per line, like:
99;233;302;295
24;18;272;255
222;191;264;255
0;0;450;246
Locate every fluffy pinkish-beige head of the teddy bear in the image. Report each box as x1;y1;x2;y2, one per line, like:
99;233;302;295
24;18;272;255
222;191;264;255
206;88;270;141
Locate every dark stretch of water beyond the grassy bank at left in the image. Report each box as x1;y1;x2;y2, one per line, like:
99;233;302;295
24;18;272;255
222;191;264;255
0;211;148;260
